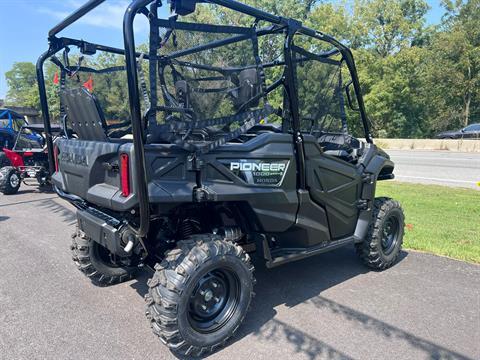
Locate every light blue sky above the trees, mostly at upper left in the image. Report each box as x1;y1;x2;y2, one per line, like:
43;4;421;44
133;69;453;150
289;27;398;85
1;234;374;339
0;0;443;99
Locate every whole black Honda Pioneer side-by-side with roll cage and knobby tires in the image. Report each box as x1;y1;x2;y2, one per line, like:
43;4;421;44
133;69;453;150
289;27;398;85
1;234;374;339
37;0;404;356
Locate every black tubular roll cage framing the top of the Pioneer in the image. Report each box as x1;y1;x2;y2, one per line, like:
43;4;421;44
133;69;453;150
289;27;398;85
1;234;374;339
36;0;372;237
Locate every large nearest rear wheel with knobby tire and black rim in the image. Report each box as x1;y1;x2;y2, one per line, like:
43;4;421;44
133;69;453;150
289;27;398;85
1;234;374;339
145;234;255;356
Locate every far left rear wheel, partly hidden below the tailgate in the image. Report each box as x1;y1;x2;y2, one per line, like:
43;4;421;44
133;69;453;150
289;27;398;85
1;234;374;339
71;230;137;286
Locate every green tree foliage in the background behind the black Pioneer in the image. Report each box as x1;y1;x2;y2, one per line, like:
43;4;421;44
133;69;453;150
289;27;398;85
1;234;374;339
5;0;480;137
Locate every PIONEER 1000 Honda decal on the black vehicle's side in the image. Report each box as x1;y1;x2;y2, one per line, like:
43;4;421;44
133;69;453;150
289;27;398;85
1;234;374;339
221;159;289;186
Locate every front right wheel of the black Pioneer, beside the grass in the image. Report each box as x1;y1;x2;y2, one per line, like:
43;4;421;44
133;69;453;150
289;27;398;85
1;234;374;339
355;198;405;270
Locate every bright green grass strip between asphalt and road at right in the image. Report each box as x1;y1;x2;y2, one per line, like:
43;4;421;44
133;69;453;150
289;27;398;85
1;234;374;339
376;181;480;263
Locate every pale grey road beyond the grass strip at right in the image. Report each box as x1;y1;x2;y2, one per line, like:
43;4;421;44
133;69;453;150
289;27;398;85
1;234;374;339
387;150;480;190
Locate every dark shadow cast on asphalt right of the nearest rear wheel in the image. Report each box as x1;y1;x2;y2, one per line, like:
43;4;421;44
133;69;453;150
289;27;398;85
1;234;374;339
233;247;468;360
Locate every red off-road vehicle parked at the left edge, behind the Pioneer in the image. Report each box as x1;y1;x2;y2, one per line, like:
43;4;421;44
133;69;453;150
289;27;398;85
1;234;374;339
0;124;62;195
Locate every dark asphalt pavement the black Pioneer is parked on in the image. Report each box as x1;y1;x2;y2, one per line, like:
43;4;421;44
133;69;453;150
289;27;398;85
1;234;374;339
0;190;480;360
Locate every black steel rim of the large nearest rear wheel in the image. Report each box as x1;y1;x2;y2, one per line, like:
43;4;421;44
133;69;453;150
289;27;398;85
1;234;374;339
188;268;240;333
